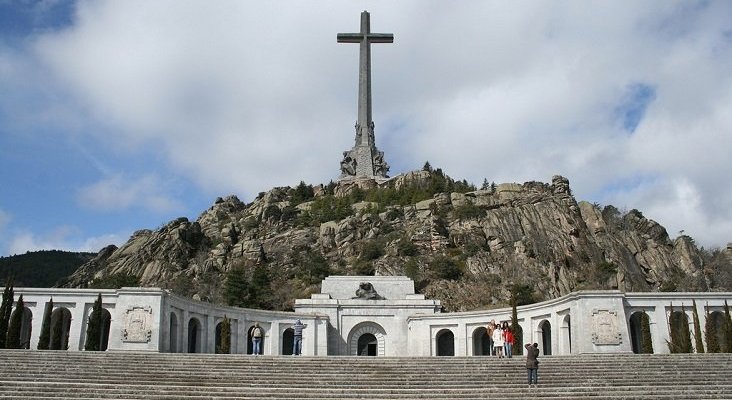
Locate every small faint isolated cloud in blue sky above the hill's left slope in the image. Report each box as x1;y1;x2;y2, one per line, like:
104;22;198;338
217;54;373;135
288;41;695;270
77;174;184;213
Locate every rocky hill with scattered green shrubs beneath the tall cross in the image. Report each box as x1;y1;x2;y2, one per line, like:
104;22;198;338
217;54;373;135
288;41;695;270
61;168;732;311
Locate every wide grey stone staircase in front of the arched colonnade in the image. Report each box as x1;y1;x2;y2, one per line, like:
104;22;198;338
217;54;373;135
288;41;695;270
0;350;732;400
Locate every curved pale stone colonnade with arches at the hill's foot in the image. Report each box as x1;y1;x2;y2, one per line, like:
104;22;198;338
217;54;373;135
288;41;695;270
10;284;732;356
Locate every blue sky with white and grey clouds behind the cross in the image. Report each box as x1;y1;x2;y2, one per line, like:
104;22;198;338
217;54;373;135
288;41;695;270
0;0;732;256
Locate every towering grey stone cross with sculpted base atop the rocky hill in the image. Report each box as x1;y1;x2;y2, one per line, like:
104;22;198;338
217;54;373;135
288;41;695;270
338;11;394;178
